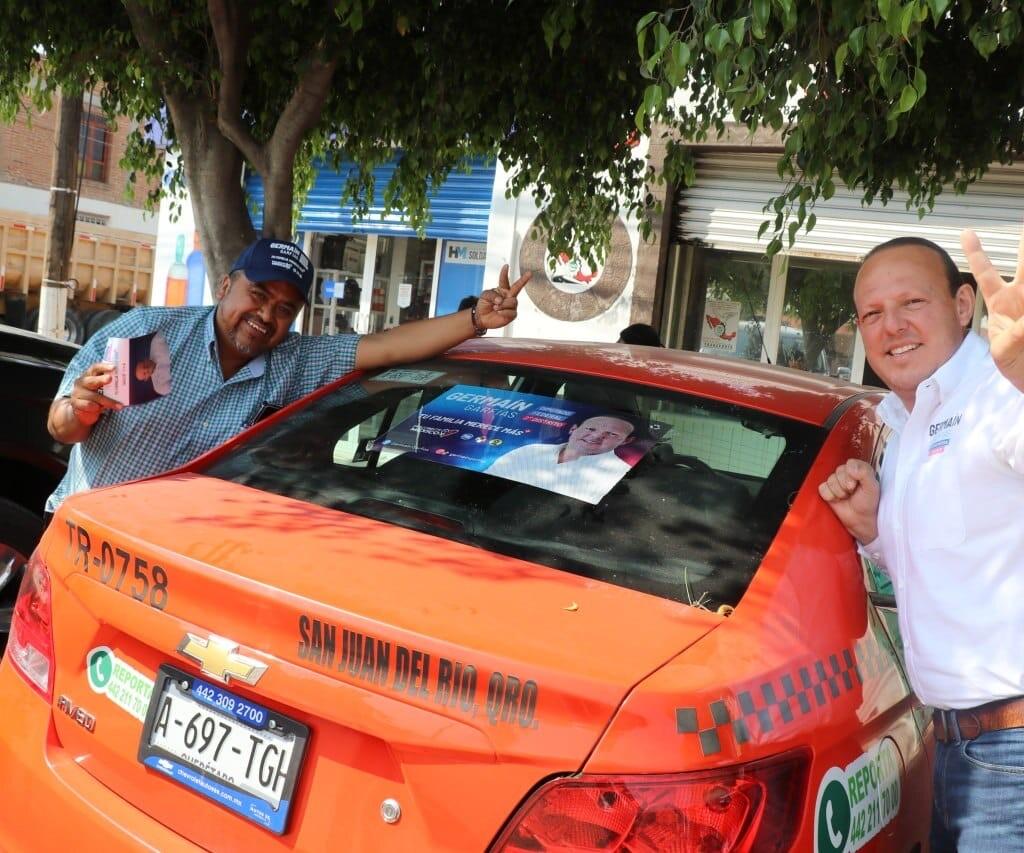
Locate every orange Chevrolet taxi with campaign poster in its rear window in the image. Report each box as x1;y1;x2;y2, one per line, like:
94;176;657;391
0;340;932;853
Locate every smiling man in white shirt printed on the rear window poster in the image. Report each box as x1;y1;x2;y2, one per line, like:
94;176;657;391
484;415;634;504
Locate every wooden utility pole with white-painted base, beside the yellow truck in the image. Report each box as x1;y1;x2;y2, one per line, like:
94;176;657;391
38;90;88;339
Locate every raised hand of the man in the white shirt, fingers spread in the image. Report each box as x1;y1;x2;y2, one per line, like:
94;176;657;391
961;221;1024;391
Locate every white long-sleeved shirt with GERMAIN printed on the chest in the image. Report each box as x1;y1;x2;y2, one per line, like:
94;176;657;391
864;333;1024;709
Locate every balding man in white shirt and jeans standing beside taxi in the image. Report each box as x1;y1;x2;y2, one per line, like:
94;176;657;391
819;231;1024;853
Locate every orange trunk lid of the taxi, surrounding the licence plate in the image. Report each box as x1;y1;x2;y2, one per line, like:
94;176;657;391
42;475;720;850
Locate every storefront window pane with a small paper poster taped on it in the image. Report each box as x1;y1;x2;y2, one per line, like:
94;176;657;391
686;250;771;361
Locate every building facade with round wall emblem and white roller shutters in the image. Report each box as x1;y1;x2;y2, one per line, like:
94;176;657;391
487;133;1024;385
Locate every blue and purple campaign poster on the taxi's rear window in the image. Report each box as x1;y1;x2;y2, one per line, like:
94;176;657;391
373;385;668;504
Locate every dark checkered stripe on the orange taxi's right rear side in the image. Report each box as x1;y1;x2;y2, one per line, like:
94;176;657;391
676;636;888;756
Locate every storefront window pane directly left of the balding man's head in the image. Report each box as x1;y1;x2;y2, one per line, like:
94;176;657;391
772;258;857;379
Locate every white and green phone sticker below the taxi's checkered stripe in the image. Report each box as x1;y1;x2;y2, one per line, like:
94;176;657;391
814;737;902;853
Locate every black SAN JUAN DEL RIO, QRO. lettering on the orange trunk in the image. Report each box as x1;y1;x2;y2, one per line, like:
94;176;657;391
298;613;540;729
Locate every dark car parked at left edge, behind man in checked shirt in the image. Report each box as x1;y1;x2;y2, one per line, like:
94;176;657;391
0;325;79;649
